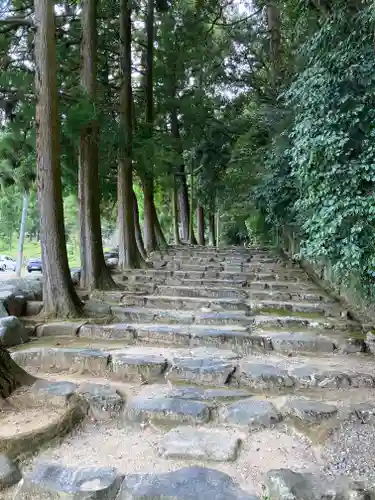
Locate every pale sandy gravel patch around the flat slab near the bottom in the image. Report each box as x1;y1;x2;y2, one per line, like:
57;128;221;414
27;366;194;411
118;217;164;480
18;423;320;494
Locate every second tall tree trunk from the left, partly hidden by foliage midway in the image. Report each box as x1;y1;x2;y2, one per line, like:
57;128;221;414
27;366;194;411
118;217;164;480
79;0;115;290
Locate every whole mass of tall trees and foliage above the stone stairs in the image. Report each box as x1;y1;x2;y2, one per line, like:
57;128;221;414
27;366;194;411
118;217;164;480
0;0;375;316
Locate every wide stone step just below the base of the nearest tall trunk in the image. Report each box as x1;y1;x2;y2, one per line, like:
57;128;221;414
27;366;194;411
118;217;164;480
24;322;356;355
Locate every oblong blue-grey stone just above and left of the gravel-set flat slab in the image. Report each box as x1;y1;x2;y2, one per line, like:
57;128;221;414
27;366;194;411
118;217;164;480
124;396;211;424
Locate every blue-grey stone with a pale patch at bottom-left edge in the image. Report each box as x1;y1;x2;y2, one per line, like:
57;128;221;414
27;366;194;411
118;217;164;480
15;463;123;500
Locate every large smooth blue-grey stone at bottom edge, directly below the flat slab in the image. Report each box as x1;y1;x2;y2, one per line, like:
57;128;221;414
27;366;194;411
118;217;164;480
118;467;259;500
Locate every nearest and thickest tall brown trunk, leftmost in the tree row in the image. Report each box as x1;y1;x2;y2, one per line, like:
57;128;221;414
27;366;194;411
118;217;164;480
34;0;81;317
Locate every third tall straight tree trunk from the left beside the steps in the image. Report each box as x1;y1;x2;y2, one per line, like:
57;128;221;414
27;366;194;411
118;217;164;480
117;0;140;268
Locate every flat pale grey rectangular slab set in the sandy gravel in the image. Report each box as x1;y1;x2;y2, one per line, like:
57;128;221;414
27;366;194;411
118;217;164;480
159;426;241;462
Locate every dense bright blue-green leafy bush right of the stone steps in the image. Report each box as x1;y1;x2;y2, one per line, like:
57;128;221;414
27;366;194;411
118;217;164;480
257;2;375;290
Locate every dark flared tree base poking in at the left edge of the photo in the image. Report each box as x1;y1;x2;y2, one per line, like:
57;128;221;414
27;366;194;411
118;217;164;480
0;346;36;399
